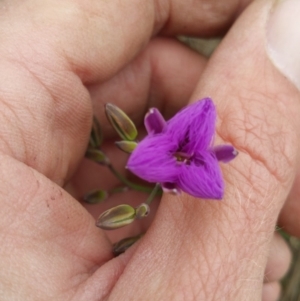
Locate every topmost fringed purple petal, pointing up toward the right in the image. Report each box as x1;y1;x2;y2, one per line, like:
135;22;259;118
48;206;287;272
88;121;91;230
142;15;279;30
167;98;216;155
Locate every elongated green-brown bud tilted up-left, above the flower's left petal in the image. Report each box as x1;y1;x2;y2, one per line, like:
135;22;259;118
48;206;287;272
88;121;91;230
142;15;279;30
105;103;138;141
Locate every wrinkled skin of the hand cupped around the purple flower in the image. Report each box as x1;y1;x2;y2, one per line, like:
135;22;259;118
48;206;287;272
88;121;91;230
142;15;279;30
0;0;300;301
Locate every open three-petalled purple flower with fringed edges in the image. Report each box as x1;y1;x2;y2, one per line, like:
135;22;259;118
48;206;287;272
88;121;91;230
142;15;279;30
127;98;237;199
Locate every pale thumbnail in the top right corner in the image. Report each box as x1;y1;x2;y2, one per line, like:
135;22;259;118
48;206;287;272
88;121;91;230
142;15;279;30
267;0;300;90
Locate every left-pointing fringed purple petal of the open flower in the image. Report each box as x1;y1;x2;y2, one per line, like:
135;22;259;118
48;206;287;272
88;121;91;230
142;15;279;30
127;134;180;183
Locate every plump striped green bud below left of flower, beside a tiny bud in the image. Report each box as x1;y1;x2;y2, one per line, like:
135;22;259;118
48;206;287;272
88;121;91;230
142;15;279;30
96;205;135;230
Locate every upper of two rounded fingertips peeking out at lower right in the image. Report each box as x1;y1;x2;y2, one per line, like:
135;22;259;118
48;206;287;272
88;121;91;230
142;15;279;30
265;233;292;283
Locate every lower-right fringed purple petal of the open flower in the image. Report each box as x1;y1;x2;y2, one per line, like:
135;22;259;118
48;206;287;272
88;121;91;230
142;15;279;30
177;152;224;200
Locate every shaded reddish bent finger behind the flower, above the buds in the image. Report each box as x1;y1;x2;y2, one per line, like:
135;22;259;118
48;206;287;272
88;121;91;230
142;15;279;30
88;38;206;138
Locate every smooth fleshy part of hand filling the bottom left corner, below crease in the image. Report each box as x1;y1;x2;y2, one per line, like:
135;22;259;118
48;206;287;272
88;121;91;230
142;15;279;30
0;155;113;300
